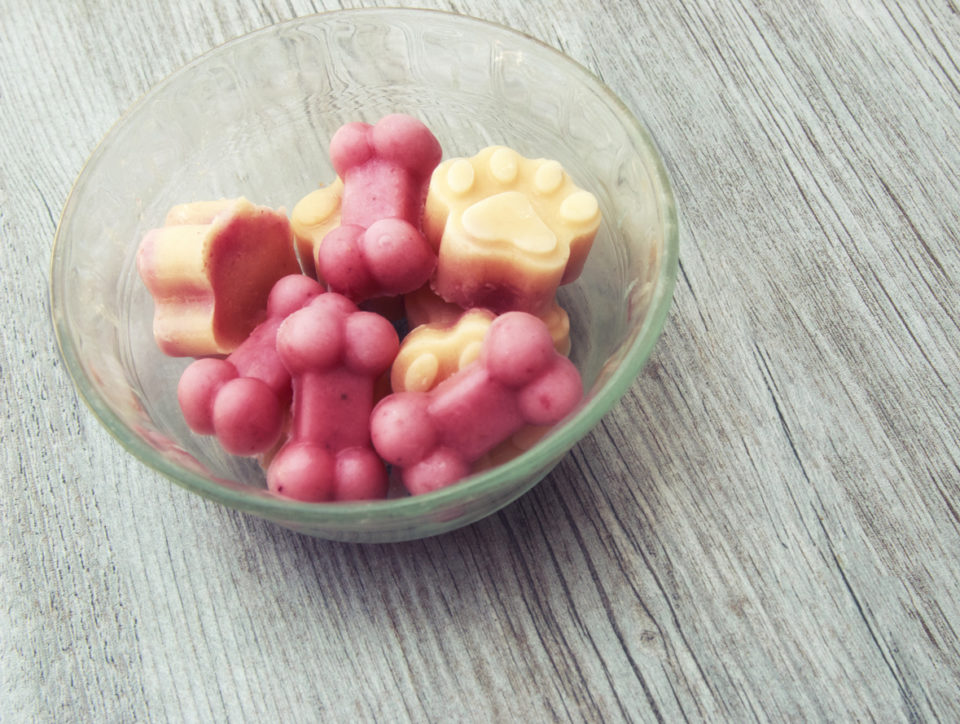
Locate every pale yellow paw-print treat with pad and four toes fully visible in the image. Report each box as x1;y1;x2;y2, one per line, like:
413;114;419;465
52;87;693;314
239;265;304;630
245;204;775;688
423;146;600;314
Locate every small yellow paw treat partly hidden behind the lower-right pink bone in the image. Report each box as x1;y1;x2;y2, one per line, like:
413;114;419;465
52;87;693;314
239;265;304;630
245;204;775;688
390;309;495;392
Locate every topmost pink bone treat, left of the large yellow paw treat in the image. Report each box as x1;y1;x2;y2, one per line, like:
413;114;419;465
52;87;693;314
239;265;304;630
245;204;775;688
316;114;442;302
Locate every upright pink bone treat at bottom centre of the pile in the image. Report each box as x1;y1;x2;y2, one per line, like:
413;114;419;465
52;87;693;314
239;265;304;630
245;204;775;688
267;292;399;502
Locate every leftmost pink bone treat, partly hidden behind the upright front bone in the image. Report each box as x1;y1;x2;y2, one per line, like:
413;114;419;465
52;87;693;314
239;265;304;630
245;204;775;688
177;274;323;455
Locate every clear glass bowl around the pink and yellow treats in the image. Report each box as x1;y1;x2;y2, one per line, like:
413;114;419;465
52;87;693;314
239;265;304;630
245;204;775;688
50;9;678;541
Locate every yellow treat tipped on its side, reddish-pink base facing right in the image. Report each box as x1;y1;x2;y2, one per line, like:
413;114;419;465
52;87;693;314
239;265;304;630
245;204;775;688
137;198;300;357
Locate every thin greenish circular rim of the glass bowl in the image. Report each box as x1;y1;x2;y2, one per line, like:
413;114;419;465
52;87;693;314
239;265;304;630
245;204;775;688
48;7;679;531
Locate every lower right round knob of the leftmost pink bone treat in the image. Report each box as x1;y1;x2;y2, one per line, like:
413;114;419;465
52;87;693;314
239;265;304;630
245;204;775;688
213;377;283;455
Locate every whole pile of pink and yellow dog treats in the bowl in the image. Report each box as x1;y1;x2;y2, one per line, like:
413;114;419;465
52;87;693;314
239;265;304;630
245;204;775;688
137;114;600;501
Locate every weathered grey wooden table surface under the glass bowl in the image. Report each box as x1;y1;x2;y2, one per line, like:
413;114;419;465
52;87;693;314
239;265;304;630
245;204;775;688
0;0;960;722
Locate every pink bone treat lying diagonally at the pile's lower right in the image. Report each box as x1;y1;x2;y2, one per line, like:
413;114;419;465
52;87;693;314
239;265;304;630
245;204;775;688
370;312;583;495
